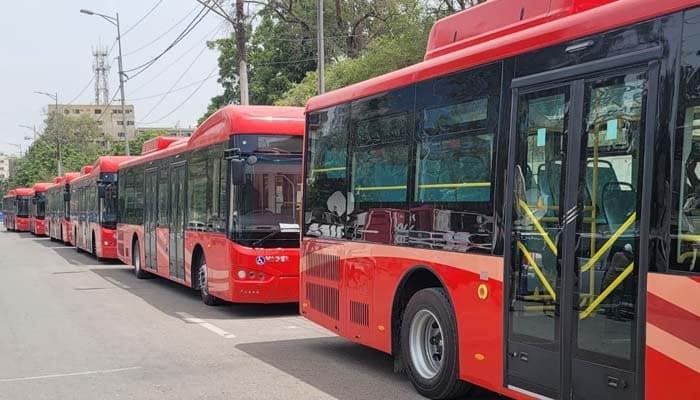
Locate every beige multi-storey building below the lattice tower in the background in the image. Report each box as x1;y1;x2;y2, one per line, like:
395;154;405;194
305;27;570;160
48;104;136;139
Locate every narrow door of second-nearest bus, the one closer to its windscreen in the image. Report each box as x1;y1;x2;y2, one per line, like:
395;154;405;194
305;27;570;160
169;163;187;280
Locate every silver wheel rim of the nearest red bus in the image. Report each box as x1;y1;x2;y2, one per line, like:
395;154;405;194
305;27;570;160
409;310;444;379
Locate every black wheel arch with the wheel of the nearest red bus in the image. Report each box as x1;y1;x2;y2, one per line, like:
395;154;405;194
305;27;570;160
391;266;470;399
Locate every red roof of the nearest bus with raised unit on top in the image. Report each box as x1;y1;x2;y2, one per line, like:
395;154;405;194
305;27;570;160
306;0;697;112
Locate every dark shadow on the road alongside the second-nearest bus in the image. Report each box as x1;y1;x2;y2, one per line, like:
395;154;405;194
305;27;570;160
90;266;299;319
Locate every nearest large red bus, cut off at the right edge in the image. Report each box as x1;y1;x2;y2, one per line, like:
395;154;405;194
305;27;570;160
300;0;700;399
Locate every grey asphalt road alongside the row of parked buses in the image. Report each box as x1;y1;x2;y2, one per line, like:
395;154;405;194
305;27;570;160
0;229;504;400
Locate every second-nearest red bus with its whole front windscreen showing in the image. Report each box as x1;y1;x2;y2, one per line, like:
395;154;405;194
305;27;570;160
117;106;304;305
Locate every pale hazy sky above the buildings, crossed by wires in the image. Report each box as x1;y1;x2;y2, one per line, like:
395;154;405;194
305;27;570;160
0;0;231;154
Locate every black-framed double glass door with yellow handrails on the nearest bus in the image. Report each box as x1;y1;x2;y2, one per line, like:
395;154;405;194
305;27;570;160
505;52;660;399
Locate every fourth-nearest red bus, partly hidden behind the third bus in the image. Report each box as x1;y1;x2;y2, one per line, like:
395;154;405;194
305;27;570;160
46;172;80;243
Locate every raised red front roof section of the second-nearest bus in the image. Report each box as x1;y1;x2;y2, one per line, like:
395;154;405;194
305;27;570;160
188;105;305;149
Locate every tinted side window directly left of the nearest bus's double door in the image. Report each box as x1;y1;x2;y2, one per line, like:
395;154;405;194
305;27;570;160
410;63;501;252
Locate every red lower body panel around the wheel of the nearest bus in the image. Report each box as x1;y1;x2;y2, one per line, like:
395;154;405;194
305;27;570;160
300;238;514;395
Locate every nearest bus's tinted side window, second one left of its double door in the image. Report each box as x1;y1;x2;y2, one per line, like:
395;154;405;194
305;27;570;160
347;87;415;244
